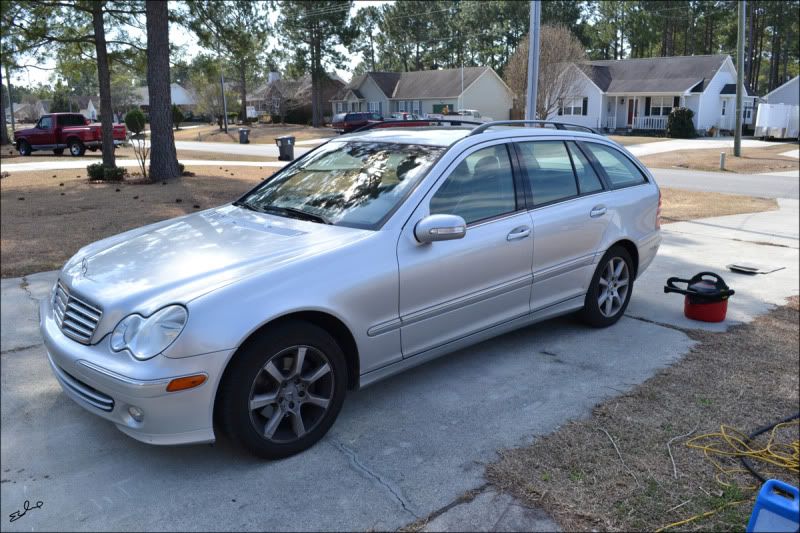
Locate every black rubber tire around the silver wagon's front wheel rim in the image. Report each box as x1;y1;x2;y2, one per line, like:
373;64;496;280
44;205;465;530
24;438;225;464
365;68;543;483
217;321;347;459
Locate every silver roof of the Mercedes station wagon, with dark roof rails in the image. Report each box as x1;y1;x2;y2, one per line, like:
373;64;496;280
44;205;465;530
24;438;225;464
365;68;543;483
339;125;609;146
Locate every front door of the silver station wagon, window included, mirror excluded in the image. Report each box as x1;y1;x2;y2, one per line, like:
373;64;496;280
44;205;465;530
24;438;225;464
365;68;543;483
397;141;533;357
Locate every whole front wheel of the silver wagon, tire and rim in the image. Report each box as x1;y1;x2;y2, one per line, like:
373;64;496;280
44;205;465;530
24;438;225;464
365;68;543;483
219;322;347;459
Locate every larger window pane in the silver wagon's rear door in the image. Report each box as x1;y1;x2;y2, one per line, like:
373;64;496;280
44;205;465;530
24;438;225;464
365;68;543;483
519;141;578;206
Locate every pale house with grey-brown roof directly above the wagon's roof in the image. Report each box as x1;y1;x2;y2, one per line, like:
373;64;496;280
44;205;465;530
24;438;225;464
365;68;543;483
331;67;513;120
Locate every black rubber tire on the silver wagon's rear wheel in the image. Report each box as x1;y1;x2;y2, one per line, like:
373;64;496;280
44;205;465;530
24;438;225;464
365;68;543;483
580;246;634;328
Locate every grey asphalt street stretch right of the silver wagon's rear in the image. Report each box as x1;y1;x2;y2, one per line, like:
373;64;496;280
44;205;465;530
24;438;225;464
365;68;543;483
650;168;800;199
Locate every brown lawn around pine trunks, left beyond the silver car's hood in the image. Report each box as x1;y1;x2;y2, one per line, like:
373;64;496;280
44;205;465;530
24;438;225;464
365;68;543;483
0;166;275;278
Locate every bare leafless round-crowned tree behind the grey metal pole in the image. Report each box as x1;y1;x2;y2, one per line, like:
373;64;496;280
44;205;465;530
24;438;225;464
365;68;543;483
504;26;586;119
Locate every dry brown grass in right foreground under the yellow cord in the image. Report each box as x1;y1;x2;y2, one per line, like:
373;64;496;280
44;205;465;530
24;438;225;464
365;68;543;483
487;297;800;531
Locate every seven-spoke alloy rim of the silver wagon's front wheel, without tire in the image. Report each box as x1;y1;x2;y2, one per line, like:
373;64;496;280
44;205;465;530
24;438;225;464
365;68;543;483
248;345;334;444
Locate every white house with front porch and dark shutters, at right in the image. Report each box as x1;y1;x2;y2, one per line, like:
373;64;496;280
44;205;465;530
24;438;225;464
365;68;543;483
547;55;758;131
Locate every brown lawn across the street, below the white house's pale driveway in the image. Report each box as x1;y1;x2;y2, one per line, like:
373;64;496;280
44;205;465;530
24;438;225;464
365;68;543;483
639;143;800;174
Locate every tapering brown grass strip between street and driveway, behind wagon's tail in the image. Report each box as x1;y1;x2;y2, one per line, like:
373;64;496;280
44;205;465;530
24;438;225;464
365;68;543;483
661;188;778;224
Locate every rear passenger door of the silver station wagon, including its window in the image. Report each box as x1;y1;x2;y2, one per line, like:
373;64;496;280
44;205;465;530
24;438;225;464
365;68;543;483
515;140;610;312
